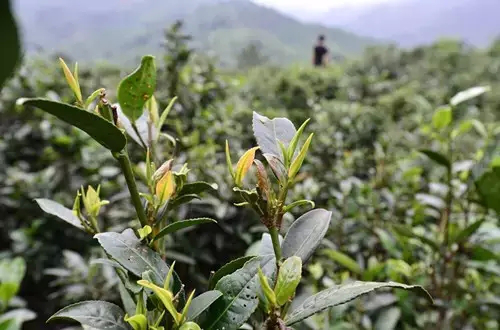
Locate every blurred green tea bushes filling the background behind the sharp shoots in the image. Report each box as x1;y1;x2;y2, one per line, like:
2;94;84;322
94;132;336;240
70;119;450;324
0;19;500;330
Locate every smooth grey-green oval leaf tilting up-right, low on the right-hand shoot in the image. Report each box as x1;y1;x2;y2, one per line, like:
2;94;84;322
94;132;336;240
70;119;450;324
281;209;332;264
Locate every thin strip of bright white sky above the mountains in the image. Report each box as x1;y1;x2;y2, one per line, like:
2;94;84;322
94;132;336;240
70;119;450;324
254;0;400;11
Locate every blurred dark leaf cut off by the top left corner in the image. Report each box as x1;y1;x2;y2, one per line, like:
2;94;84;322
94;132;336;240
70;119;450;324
0;0;21;91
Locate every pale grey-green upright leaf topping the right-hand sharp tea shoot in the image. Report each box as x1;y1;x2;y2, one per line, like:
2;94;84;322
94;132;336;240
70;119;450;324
252;112;297;162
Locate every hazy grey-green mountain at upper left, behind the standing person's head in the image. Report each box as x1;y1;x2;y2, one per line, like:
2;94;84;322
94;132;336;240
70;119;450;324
11;0;375;65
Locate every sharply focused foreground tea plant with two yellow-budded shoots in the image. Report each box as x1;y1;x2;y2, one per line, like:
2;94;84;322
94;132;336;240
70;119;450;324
19;56;431;330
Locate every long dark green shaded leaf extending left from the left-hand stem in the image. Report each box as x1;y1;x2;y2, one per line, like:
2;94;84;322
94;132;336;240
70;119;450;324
19;99;126;152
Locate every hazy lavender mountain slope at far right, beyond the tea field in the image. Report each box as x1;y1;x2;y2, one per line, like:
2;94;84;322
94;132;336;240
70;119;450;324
314;0;500;46
